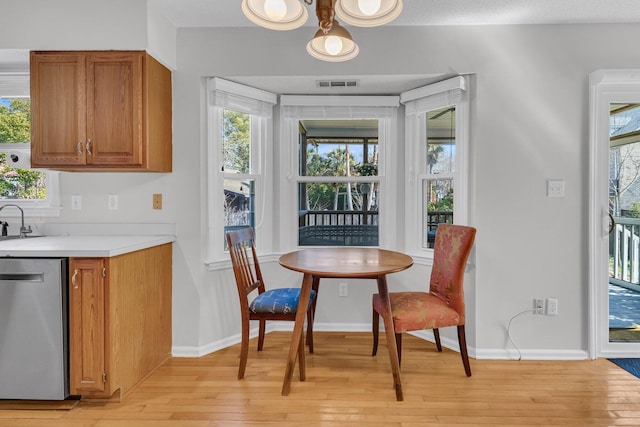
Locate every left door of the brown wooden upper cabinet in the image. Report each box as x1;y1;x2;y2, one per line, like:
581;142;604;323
31;52;86;167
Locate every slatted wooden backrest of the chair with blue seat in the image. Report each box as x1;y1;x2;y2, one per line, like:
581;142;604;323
226;228;264;300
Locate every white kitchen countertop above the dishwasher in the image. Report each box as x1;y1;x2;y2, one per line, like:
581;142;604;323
0;235;176;257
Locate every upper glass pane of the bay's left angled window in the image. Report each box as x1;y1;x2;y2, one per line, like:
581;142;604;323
222;110;251;173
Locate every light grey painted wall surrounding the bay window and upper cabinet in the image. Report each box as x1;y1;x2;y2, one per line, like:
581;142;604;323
0;0;640;357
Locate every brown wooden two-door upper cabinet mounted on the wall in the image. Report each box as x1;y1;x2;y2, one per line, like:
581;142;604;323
31;51;172;172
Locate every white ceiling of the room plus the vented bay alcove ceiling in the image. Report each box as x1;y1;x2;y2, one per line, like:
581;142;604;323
149;0;640;95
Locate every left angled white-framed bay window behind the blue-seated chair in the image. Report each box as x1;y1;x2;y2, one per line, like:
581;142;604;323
207;78;277;265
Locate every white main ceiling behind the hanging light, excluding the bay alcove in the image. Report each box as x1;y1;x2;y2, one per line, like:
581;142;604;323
149;0;640;27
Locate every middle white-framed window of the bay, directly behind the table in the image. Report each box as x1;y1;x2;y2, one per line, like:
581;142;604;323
279;95;399;249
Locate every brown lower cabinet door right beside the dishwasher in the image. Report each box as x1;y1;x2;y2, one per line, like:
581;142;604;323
69;258;106;394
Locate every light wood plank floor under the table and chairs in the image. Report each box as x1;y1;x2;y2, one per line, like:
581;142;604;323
0;332;640;427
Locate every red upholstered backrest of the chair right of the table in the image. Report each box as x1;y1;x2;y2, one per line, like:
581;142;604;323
429;224;476;324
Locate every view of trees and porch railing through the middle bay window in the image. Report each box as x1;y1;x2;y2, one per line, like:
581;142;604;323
298;126;379;246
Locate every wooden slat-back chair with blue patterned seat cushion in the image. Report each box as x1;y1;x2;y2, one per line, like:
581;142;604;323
226;227;318;380
